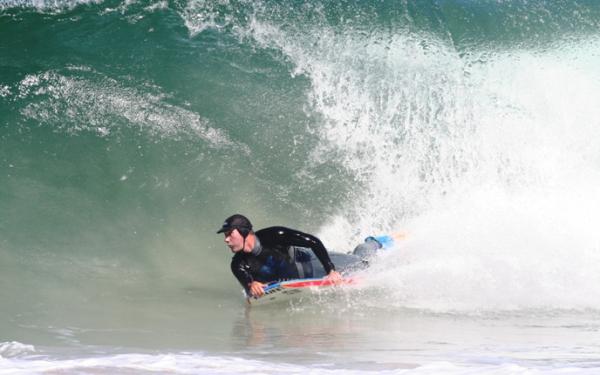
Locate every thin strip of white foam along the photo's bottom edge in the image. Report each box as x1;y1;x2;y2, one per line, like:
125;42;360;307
0;353;597;375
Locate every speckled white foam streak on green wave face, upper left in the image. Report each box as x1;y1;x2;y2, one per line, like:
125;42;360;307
16;67;248;152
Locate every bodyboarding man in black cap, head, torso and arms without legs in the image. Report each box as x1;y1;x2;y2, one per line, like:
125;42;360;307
217;214;342;297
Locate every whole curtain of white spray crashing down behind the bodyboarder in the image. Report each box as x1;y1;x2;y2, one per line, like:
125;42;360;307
233;10;600;311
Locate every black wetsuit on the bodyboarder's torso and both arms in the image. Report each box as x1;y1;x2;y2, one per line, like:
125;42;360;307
231;227;335;290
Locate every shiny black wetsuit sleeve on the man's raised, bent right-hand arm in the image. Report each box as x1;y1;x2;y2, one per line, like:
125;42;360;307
256;227;335;273
